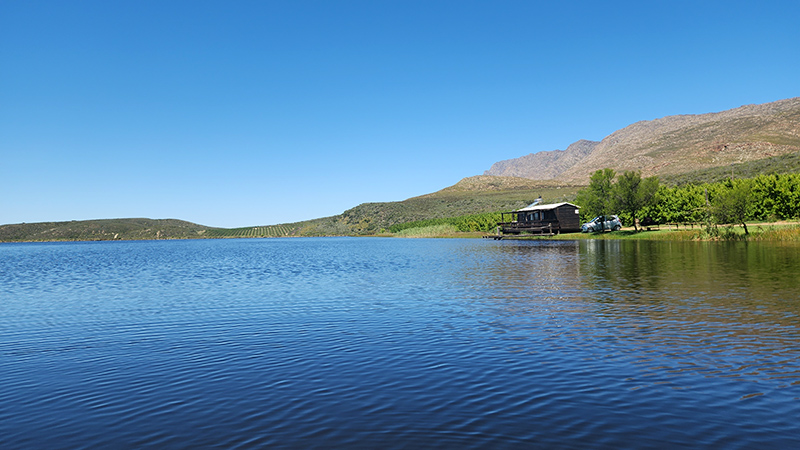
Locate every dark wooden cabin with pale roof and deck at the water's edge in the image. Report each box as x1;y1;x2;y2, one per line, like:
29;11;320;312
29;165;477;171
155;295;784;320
497;202;581;234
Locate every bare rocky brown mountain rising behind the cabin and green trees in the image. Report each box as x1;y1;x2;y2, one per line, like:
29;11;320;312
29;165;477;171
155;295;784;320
484;97;800;183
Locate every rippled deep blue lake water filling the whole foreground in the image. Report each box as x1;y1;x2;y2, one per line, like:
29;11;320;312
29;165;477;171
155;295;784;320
0;238;800;449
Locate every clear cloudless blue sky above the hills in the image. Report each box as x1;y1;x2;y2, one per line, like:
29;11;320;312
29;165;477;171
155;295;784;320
0;0;800;227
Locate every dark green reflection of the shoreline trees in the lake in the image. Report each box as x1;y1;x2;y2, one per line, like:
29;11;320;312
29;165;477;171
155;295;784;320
580;240;800;317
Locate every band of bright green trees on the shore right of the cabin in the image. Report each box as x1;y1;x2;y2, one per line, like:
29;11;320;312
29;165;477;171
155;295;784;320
575;169;800;233
